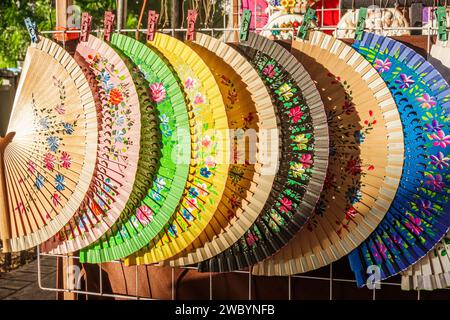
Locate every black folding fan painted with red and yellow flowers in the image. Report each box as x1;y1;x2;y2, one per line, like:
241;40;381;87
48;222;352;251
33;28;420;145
200;34;329;272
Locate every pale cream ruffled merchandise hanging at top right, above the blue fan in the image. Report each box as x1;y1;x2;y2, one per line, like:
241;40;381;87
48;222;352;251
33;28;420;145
334;7;410;39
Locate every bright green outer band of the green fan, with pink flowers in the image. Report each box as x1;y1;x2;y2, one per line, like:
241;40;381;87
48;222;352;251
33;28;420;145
71;34;191;262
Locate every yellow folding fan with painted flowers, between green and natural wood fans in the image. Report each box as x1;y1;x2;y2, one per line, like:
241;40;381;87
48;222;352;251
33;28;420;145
126;33;230;264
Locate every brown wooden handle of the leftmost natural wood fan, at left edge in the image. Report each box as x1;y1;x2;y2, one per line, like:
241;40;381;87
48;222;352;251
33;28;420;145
0;132;16;252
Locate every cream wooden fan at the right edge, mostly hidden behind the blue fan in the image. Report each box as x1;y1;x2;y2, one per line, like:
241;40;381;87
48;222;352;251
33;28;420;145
402;42;450;290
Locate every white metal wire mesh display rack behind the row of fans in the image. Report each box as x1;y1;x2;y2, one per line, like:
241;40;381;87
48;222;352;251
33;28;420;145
30;6;450;300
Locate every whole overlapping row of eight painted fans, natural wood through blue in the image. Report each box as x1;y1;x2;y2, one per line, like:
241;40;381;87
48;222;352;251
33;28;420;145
0;26;450;286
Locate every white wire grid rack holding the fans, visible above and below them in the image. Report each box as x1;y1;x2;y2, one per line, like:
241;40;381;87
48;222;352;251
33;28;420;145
33;6;450;300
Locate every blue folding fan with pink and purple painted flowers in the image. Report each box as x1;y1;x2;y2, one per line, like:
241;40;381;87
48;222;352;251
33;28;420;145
349;34;450;286
